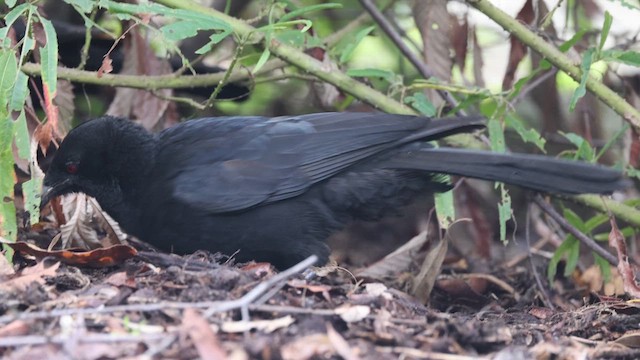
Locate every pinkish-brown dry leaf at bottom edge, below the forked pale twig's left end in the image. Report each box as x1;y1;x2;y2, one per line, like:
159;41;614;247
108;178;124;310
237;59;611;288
182;308;227;360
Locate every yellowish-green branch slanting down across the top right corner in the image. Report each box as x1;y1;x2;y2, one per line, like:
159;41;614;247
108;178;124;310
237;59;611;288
467;0;640;131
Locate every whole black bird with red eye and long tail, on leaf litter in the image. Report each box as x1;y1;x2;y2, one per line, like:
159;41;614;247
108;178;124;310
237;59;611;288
42;113;626;268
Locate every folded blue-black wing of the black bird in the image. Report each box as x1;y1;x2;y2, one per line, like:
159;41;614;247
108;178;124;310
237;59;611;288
157;113;483;213
